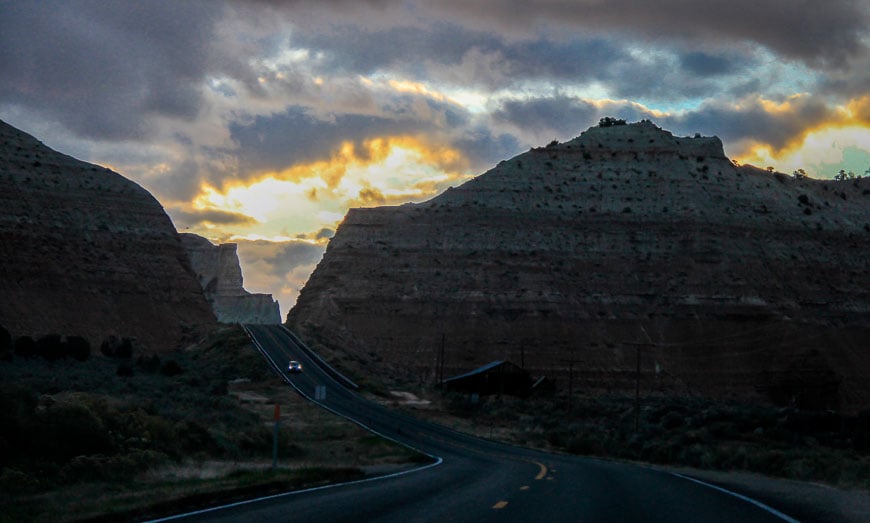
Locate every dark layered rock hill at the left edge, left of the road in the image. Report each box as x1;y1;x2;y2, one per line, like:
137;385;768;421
0;122;215;351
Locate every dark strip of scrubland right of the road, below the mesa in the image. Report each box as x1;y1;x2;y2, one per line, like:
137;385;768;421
382;391;870;489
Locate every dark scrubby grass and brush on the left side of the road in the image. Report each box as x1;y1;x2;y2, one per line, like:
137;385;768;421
0;327;419;521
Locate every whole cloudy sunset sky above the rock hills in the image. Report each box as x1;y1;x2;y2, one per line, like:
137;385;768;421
0;0;870;314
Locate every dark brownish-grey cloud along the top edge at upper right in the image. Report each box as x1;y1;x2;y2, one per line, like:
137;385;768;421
426;0;870;66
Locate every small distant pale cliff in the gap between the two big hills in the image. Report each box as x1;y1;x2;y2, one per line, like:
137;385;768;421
181;233;281;324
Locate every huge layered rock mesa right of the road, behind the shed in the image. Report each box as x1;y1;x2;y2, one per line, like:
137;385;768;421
287;122;870;410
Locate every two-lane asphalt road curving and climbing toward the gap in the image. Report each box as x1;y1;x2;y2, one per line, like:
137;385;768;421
155;326;797;523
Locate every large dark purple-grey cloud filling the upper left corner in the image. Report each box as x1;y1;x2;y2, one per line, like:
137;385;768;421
0;1;221;140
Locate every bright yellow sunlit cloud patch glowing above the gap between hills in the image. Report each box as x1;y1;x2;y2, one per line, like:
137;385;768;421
192;136;470;239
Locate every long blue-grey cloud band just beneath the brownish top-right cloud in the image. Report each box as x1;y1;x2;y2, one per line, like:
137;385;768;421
282;14;757;101
